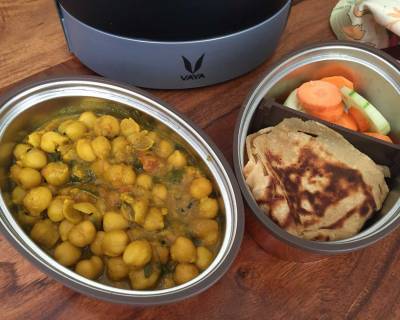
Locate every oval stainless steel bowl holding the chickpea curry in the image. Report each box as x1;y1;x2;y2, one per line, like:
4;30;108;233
0;77;244;305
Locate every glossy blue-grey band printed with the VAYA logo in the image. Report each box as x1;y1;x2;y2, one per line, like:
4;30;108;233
57;0;291;89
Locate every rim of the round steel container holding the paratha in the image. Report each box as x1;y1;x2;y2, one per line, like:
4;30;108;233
233;41;400;255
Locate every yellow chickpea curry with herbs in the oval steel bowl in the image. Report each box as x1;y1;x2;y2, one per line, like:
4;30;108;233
10;111;224;290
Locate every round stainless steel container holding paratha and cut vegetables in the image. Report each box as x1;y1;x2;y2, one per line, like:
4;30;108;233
234;42;400;259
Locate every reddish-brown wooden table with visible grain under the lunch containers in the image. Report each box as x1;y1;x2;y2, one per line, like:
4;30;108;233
0;0;400;320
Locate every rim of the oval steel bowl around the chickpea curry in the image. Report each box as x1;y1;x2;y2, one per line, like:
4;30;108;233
0;76;244;305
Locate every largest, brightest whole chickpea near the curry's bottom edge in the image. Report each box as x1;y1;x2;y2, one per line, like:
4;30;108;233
122;240;152;268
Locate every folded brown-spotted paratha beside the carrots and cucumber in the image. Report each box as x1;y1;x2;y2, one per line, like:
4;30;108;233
244;118;389;241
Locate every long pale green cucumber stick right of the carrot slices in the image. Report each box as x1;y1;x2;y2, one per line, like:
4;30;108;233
340;86;390;135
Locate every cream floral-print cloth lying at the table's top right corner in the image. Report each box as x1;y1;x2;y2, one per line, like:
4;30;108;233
330;0;400;49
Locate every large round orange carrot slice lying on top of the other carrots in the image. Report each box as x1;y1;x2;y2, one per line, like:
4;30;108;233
297;80;342;112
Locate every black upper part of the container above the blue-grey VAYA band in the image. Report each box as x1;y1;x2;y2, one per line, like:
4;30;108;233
58;0;289;41
